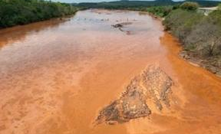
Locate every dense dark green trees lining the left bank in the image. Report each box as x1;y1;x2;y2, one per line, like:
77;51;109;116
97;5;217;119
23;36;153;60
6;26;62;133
0;0;77;28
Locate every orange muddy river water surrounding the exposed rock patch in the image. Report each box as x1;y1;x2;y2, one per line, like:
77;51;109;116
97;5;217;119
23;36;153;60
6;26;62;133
0;10;221;134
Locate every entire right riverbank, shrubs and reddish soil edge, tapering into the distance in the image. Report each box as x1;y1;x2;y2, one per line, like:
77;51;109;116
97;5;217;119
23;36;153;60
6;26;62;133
79;2;221;77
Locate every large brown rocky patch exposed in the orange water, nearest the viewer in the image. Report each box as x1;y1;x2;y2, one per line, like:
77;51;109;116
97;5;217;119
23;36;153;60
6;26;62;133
96;65;172;124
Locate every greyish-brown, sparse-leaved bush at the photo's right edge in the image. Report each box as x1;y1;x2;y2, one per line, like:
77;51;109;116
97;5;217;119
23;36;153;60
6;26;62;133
185;20;221;56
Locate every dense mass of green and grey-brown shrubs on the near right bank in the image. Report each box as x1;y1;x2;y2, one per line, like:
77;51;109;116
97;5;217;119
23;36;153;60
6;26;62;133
163;3;221;72
